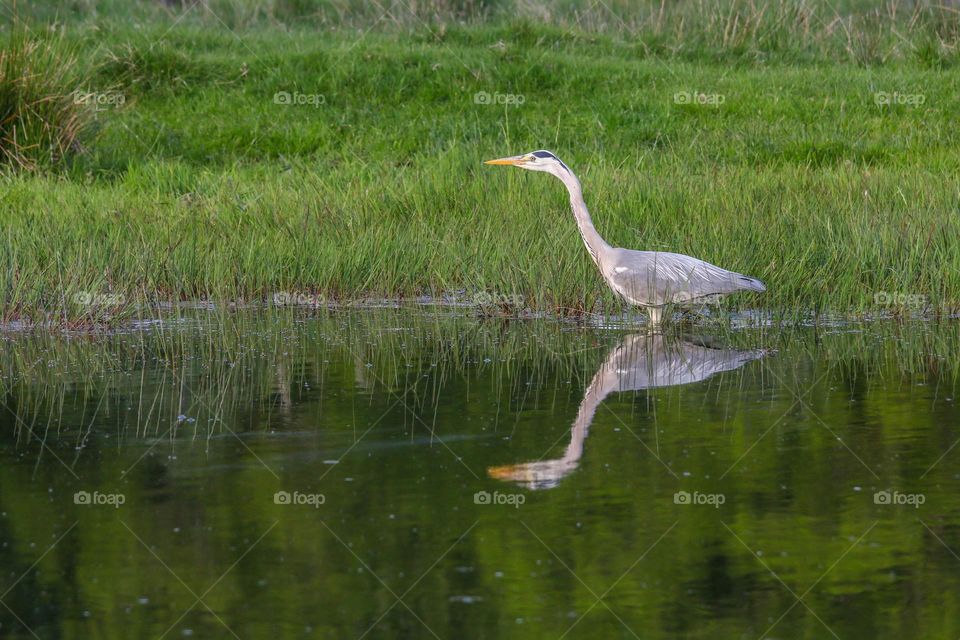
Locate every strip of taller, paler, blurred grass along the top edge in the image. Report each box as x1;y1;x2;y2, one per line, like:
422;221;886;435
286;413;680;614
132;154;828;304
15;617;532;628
11;0;960;66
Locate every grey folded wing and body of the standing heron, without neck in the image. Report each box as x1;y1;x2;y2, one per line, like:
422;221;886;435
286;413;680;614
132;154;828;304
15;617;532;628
608;249;766;306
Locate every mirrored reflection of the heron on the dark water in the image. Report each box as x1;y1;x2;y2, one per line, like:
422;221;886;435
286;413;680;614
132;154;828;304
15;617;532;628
487;334;765;489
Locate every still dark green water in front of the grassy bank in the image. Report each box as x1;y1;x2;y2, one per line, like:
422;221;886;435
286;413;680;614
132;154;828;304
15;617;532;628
0;310;960;640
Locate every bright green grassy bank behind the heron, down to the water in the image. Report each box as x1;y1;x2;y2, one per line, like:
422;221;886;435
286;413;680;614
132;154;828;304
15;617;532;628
0;3;960;322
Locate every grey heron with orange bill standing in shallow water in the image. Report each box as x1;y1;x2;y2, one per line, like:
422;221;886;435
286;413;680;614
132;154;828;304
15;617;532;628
486;150;767;328
